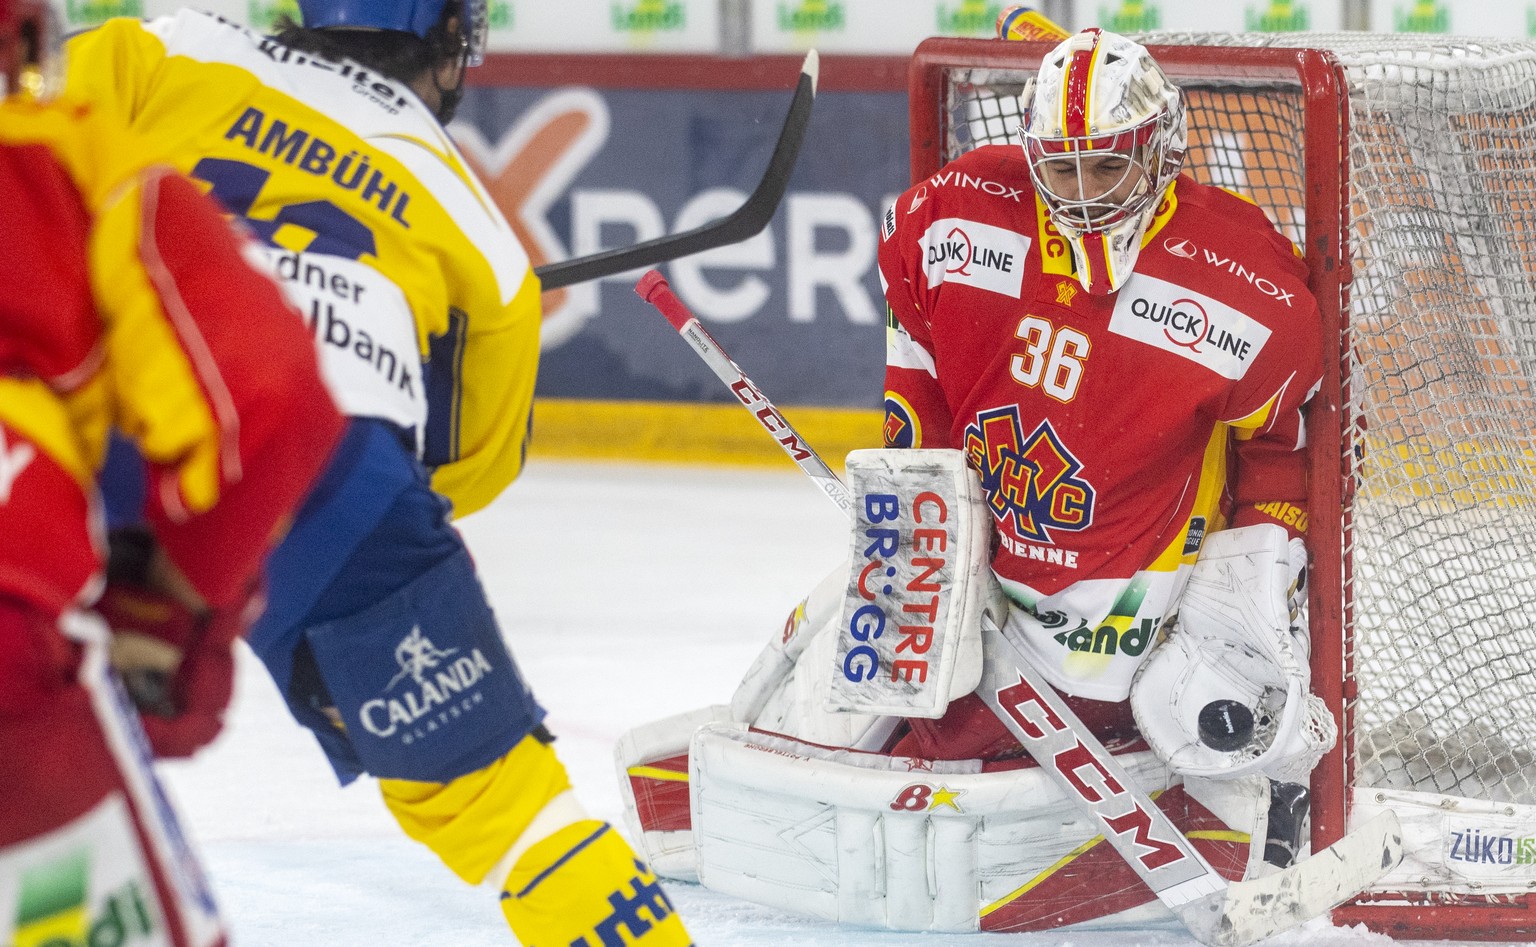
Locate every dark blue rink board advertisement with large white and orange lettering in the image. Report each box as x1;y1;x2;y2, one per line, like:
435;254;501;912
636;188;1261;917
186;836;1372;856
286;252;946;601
452;57;908;411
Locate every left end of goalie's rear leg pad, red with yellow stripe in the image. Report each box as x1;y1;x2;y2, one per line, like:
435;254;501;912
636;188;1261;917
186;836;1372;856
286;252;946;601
613;704;731;881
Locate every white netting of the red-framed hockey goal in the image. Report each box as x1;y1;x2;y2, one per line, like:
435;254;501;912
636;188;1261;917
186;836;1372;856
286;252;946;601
940;34;1536;822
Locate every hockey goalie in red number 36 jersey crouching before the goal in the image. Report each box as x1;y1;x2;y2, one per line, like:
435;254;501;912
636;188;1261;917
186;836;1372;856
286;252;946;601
619;29;1335;932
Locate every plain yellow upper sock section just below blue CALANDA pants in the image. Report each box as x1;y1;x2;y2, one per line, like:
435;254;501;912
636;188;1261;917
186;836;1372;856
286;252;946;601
379;734;570;884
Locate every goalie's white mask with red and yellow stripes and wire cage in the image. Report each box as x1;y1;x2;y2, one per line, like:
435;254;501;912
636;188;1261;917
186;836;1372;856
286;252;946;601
1018;29;1186;295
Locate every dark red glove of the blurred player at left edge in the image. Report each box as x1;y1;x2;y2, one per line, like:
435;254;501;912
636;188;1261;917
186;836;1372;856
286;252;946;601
95;530;261;757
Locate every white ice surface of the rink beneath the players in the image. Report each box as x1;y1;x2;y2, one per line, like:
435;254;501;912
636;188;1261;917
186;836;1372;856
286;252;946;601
155;460;1474;947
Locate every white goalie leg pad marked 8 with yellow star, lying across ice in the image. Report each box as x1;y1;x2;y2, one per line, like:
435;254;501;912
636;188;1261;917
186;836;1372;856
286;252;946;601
690;724;1170;932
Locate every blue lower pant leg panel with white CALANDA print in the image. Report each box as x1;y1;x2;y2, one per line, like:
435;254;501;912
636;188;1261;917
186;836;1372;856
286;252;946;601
306;549;544;783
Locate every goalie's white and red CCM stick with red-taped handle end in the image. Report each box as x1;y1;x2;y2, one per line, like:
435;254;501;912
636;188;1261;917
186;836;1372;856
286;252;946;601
634;270;1402;947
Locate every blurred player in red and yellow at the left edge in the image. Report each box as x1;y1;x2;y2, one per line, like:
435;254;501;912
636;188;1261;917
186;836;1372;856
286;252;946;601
0;0;343;947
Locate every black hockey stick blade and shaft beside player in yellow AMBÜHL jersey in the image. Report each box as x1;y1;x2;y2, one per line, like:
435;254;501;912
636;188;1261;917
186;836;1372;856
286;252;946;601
533;49;820;290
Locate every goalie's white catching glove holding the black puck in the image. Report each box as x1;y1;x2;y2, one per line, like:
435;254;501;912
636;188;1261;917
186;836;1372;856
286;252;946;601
1130;523;1338;783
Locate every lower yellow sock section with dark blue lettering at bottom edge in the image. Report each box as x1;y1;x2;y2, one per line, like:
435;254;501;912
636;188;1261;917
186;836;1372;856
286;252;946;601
501;820;693;947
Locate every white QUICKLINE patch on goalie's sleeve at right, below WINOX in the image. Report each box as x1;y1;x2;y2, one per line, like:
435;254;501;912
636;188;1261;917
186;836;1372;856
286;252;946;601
1109;273;1270;379
